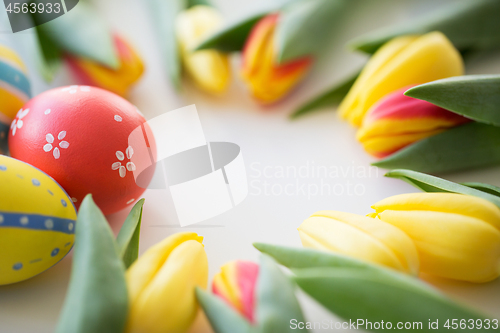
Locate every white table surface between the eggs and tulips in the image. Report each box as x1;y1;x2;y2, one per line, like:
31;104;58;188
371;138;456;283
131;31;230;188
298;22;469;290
0;0;500;333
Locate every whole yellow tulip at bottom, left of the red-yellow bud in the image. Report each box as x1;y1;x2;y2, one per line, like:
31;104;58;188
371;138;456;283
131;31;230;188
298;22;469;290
126;232;208;333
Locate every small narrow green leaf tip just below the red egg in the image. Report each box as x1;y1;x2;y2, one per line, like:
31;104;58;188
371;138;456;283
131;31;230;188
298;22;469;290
116;199;144;268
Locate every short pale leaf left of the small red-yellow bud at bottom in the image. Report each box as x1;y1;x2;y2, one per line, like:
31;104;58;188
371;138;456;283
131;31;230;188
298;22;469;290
196;287;252;333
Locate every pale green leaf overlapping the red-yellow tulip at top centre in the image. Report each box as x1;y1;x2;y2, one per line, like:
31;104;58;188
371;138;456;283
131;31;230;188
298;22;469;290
275;0;348;63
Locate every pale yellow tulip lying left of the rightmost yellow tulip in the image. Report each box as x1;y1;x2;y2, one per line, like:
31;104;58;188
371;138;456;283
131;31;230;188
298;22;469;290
298;210;419;275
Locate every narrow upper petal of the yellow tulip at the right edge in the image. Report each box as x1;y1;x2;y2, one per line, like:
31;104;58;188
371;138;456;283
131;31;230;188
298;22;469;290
372;193;500;230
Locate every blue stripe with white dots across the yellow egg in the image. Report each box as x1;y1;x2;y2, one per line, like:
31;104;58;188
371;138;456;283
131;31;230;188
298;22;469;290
0;212;75;234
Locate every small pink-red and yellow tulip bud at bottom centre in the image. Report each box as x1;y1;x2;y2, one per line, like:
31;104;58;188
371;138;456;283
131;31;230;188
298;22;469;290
212;260;259;323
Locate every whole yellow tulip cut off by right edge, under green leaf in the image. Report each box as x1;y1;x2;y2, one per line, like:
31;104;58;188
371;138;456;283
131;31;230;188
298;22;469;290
372;193;500;282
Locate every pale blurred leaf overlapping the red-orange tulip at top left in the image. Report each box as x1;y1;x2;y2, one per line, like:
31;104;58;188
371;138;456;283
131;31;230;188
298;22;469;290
37;1;119;69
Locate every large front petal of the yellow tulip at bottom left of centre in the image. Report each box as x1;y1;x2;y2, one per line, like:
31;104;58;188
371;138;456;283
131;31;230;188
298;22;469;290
127;240;208;333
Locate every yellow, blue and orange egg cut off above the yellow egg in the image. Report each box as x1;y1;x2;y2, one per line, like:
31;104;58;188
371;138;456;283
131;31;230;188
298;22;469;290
0;45;30;154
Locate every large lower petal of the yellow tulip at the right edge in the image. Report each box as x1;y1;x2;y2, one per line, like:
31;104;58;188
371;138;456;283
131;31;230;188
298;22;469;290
378;209;500;282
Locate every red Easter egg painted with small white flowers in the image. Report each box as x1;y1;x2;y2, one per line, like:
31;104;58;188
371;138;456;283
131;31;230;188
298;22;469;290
9;86;155;214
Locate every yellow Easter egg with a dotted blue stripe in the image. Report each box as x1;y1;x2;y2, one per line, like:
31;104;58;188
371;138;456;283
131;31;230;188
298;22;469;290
0;156;76;285
